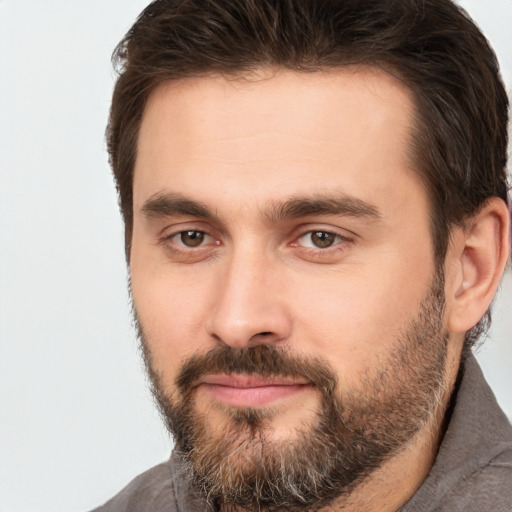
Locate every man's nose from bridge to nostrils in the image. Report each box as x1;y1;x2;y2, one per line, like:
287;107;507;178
207;247;292;348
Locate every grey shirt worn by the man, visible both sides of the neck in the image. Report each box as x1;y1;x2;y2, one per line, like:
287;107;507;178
94;355;512;512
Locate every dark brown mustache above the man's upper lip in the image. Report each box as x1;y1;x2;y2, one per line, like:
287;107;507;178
175;344;338;396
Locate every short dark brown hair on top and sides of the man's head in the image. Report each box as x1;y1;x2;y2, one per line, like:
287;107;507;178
107;0;508;344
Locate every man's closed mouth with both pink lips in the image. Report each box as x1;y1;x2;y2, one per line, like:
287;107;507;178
198;375;312;408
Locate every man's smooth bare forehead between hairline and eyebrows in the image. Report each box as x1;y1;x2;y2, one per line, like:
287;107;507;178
134;68;420;220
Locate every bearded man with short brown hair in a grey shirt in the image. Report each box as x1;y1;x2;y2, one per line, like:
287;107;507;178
94;0;512;512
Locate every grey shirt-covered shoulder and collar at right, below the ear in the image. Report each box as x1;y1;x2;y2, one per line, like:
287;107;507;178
400;355;512;512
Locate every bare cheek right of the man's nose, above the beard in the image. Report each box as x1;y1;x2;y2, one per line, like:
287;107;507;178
295;254;432;386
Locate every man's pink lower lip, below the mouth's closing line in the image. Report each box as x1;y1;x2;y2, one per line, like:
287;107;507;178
201;384;309;407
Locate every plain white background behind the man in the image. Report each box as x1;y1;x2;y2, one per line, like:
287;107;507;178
0;0;512;512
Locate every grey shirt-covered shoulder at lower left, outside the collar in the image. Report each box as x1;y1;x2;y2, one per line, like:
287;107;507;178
93;461;178;512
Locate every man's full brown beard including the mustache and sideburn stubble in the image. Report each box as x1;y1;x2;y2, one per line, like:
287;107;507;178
136;272;448;512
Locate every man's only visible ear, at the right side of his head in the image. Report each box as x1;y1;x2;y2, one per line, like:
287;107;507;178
446;197;510;333
